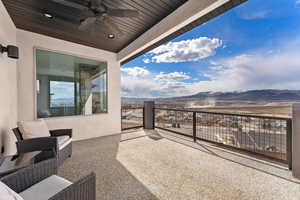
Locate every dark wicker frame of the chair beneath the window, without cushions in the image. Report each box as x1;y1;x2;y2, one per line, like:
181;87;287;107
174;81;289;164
13;128;72;166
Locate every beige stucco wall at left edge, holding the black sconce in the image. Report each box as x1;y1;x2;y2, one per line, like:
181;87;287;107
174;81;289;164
0;1;17;155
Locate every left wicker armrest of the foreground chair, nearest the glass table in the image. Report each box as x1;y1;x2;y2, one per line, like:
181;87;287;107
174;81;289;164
0;159;57;193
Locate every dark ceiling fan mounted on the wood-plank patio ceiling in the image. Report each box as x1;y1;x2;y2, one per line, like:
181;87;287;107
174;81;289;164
52;0;139;39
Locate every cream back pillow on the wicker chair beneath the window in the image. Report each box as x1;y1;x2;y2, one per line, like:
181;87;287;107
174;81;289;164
18;119;50;139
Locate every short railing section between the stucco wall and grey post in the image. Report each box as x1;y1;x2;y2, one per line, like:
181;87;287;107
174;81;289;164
121;107;144;130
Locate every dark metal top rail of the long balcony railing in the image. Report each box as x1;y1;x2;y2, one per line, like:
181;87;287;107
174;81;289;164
155;108;291;121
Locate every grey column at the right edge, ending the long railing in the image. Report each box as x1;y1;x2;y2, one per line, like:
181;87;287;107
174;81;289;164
292;103;300;179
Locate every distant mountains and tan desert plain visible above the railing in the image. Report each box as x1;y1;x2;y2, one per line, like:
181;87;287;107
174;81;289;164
122;90;300;117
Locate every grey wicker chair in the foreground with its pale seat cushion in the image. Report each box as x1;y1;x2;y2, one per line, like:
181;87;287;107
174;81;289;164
0;159;96;200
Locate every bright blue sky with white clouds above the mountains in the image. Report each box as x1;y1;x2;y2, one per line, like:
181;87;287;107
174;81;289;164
121;0;300;97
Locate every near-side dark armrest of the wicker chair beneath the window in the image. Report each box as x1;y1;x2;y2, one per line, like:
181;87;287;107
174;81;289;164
17;137;59;154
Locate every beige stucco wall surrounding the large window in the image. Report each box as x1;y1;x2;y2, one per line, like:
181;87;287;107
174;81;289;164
17;30;121;140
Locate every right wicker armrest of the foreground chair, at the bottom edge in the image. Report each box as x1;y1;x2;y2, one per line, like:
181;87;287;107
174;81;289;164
49;172;96;200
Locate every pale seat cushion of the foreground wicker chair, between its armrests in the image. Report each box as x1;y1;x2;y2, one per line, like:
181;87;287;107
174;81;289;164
20;175;72;200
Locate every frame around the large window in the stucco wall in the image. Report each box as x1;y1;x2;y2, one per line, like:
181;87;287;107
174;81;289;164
33;46;109;120
